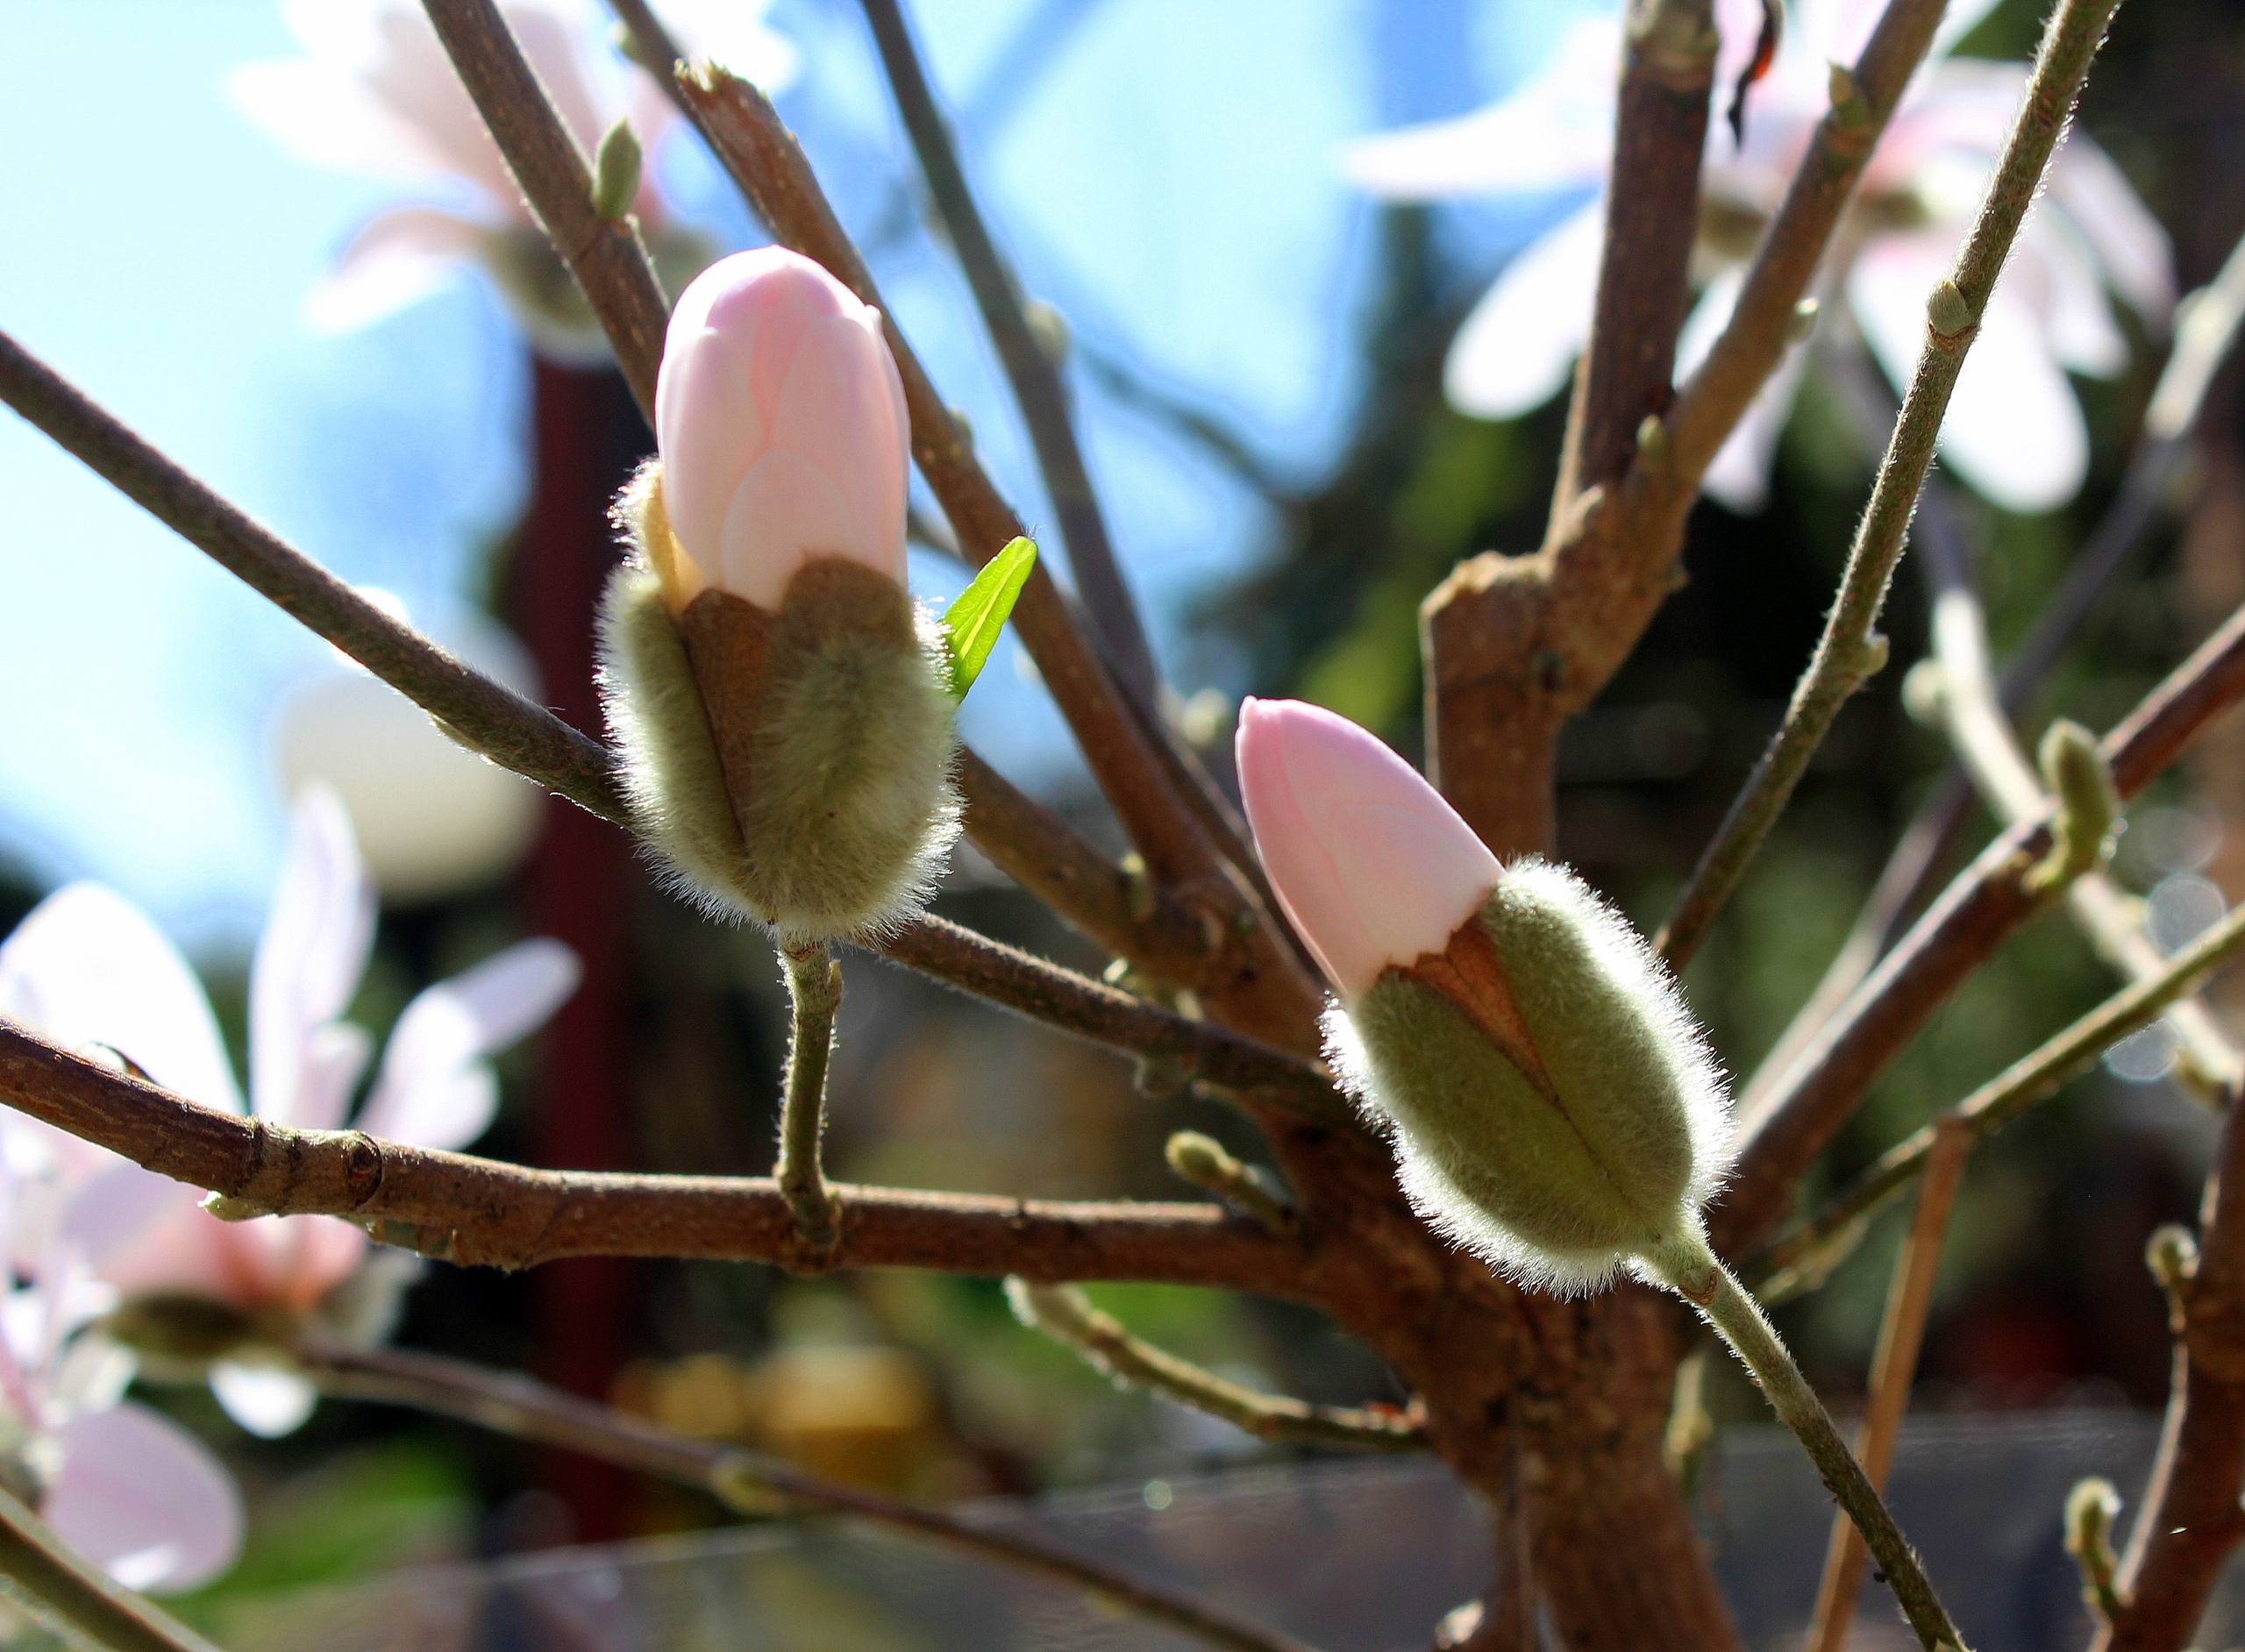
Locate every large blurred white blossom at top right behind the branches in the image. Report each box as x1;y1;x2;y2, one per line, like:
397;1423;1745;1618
1344;0;2176;509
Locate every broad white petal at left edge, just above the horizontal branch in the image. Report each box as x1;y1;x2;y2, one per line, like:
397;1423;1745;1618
0;885;242;1117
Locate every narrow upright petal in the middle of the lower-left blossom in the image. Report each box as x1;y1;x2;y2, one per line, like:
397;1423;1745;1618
249;786;375;1124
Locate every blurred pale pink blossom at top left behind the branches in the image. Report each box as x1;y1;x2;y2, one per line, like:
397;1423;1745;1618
229;0;797;361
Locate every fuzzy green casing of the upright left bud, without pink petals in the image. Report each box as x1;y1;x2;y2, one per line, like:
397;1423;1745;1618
600;530;959;945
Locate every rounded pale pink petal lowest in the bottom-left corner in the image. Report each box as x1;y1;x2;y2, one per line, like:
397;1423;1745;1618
39;1405;242;1593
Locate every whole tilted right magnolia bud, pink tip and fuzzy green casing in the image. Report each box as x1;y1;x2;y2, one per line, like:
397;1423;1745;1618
1239;701;1728;1291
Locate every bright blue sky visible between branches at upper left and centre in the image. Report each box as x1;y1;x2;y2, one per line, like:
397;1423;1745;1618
0;0;1567;947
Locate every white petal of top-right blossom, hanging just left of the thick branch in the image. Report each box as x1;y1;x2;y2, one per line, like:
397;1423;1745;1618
1442;202;1605;420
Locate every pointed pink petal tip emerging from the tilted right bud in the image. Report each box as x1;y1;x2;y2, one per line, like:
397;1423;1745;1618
1237;701;1502;999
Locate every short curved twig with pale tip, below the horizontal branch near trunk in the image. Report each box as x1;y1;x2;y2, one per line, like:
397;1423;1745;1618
1006;1279;1426;1452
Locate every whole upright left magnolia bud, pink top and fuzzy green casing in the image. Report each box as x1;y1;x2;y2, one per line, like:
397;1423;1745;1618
602;249;959;943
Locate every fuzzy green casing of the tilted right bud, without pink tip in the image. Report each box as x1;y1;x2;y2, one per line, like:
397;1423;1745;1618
1327;859;1731;1292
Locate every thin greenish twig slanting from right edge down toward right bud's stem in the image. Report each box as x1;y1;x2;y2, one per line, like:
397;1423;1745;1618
1763;907;2245;1271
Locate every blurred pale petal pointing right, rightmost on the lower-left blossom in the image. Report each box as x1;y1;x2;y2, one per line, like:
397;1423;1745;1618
360;941;581;1147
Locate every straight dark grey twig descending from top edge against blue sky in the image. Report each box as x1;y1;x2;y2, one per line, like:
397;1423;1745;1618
865;0;1161;705
